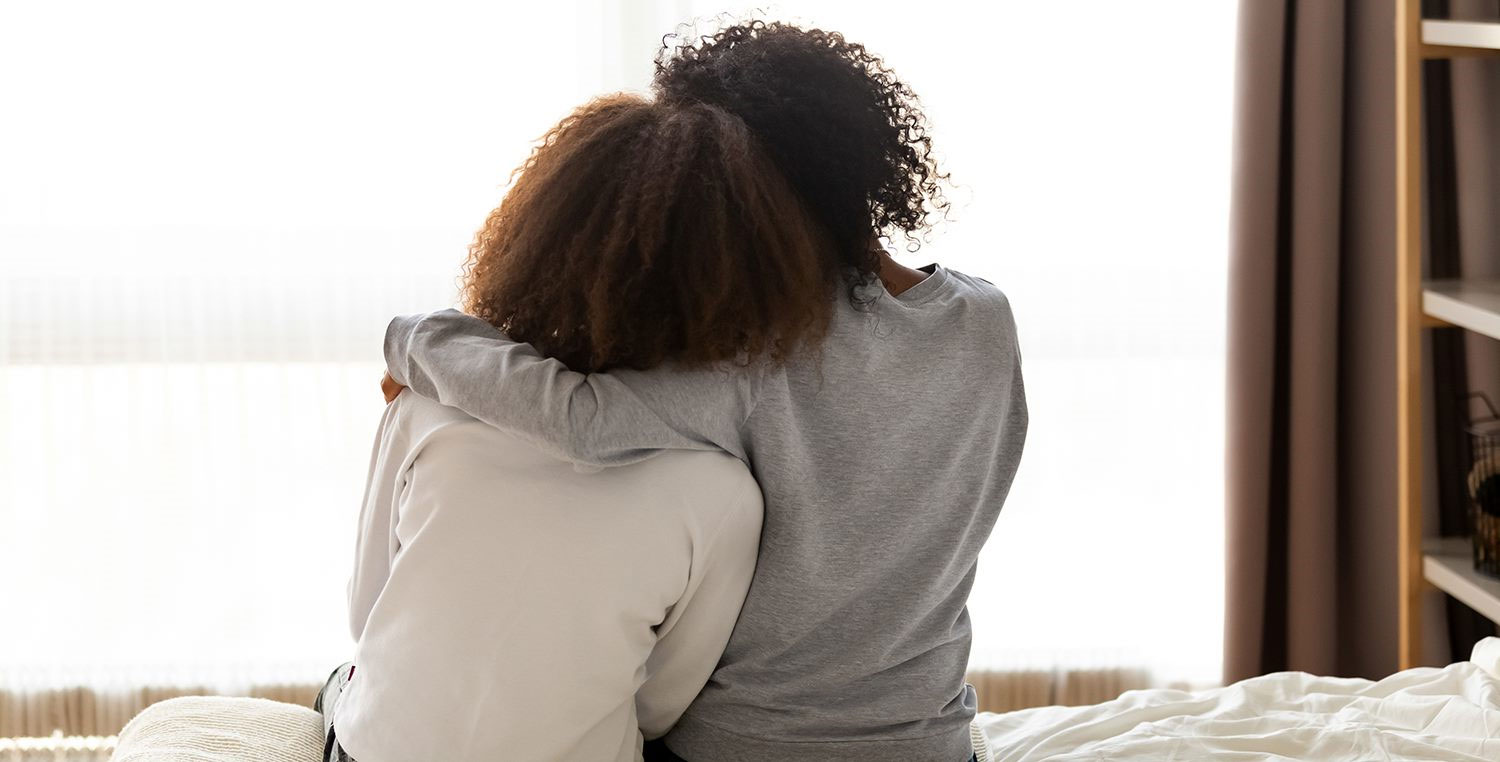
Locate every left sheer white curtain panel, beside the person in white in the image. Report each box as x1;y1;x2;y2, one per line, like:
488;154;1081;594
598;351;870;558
0;2;612;683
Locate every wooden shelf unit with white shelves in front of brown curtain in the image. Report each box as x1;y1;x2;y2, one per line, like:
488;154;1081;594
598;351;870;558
1397;8;1500;669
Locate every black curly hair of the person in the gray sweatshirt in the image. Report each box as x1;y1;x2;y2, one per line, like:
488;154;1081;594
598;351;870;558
654;20;948;288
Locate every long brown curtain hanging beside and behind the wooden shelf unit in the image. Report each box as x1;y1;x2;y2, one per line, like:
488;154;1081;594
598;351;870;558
1224;0;1496;681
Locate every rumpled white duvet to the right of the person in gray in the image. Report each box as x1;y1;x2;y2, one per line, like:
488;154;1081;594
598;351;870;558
975;638;1500;762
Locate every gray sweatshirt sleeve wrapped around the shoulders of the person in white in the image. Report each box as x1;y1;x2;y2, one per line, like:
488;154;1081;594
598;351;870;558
386;309;761;465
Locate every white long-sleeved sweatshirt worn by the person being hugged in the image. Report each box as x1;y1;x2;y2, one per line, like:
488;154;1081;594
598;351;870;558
335;393;761;762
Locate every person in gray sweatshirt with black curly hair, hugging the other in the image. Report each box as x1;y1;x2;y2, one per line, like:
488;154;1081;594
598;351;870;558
386;21;1028;762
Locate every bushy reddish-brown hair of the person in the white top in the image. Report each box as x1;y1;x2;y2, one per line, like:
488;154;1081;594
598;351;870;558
464;95;840;372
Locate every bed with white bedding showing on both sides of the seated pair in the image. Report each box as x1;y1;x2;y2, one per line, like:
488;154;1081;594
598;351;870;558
111;638;1500;762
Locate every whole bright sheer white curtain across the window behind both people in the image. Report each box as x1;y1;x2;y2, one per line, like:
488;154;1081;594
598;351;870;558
0;0;1233;696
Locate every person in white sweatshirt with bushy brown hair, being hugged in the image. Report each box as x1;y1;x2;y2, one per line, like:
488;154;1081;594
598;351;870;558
317;96;840;762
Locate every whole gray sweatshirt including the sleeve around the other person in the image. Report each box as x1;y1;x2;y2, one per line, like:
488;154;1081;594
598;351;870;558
386;266;1028;762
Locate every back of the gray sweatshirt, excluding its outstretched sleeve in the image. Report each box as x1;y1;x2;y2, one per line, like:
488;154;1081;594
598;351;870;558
668;267;1028;761
